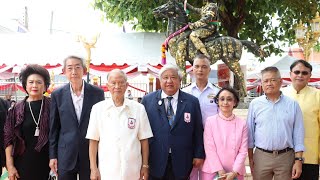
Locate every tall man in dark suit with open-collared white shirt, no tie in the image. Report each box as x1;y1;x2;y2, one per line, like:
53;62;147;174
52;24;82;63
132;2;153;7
49;56;104;180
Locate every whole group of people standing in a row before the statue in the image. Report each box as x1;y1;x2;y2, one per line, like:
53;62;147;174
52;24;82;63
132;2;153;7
0;54;320;180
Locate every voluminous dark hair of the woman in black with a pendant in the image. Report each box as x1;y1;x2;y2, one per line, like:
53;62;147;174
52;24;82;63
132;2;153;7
19;64;50;93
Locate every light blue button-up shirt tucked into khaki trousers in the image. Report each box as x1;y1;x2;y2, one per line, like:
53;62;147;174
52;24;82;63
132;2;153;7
247;94;305;152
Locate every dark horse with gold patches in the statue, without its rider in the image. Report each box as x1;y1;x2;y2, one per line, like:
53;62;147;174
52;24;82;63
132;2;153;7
153;0;266;97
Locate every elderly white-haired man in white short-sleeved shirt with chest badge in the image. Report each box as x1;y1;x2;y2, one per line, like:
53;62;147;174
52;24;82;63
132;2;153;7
86;69;153;180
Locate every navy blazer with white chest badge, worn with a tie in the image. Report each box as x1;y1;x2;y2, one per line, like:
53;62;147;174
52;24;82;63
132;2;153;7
142;90;205;177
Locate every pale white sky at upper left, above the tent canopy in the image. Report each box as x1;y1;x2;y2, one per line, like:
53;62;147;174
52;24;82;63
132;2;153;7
0;0;122;34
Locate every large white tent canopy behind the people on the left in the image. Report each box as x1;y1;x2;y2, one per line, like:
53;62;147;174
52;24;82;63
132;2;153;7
0;33;175;65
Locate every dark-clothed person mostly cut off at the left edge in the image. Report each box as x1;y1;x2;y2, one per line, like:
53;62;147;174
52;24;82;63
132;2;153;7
0;98;8;176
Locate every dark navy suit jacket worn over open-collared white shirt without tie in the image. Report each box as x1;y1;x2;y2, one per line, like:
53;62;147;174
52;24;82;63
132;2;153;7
49;83;104;171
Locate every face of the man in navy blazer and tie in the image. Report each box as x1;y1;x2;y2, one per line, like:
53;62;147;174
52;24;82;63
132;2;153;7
160;69;181;96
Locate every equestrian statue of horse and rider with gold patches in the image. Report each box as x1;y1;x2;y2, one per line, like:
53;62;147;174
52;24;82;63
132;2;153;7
153;0;266;97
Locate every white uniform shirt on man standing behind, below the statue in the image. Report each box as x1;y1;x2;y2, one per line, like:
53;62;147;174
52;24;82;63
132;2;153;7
183;82;220;126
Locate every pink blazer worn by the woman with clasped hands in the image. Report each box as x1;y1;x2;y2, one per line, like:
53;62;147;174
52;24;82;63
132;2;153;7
202;114;248;175
